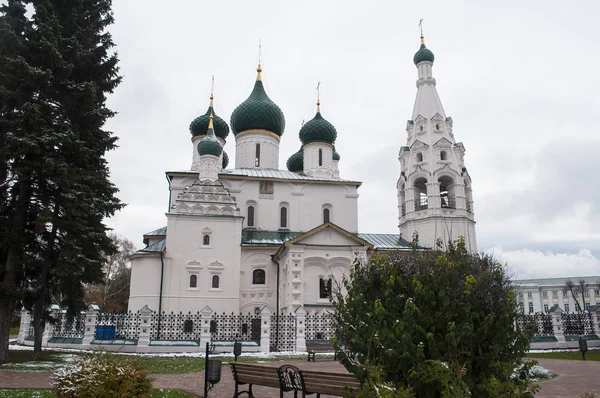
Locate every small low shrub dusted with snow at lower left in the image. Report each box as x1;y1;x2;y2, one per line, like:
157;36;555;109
54;353;151;398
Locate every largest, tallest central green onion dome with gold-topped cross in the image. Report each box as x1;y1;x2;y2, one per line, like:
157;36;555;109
231;64;285;137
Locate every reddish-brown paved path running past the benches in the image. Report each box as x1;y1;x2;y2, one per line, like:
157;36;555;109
0;359;600;398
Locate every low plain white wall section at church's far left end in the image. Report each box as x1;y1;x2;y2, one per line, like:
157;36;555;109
128;256;161;312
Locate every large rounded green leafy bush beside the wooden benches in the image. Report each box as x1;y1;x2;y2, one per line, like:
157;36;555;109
333;239;536;397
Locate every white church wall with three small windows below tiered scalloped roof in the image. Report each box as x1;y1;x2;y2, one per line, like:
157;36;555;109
163;214;241;312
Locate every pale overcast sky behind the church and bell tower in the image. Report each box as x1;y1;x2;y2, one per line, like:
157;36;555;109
103;0;600;278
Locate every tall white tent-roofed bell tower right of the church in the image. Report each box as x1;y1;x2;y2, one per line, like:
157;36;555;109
397;34;477;252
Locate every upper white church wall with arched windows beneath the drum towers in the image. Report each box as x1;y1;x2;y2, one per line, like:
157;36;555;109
223;179;358;232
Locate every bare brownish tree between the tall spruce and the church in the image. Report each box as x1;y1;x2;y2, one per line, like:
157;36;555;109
86;234;135;312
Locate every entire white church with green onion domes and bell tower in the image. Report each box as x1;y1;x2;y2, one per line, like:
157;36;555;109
129;36;477;314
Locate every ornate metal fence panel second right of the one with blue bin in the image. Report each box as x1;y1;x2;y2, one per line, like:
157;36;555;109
210;313;260;341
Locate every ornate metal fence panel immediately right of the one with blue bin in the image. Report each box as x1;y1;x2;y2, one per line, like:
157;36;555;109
150;312;201;341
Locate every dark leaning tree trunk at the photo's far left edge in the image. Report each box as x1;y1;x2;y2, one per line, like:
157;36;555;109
0;183;31;364
